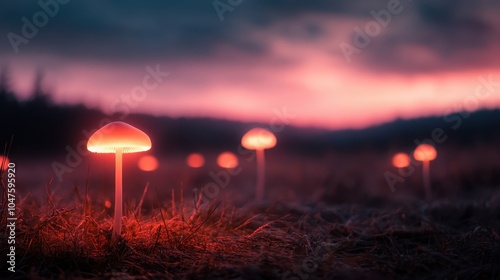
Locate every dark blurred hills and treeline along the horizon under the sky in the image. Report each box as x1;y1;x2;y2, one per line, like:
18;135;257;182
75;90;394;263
0;76;500;160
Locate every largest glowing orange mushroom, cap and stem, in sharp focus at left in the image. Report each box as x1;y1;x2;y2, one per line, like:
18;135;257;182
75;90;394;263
87;122;151;240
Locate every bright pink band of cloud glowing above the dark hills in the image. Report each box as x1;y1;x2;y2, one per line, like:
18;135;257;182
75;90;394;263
6;17;500;131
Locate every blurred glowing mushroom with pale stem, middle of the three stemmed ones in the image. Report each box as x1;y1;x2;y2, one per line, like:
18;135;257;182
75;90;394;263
241;128;276;201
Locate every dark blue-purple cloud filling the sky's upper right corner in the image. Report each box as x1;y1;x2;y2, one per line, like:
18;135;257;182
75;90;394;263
361;0;500;73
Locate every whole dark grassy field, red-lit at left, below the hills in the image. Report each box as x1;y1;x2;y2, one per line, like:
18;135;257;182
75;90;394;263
1;151;500;279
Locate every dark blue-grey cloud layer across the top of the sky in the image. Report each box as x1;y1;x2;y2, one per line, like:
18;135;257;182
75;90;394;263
0;0;500;73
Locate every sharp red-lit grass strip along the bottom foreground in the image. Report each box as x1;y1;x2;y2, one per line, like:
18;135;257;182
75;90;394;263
0;180;500;279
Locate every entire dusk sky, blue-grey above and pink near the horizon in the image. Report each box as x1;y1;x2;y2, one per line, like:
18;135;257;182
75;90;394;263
0;0;500;129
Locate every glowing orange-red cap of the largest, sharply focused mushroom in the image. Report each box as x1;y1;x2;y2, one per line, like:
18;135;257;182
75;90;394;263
87;122;151;154
